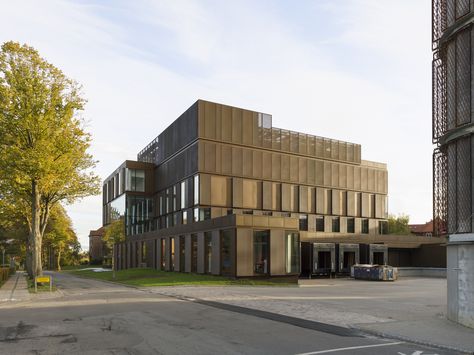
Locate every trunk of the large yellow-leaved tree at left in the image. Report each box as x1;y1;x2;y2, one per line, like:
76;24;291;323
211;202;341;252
30;180;43;277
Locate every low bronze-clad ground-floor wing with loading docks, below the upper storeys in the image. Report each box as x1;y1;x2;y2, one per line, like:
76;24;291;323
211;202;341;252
114;215;446;277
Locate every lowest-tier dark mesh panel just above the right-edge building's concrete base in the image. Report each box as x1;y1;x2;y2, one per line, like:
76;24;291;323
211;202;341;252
456;137;471;233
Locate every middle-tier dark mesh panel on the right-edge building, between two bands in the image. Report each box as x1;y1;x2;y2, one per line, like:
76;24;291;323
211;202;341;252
456;28;471;126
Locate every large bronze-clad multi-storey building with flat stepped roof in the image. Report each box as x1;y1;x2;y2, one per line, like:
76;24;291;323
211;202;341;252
103;100;439;277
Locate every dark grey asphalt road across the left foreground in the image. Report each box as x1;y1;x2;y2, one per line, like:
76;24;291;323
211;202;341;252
0;274;462;355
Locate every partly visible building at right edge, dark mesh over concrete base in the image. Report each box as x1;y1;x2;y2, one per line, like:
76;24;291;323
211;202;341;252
432;0;474;327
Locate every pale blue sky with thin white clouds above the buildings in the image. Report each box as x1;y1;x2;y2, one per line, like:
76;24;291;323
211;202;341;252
0;0;433;250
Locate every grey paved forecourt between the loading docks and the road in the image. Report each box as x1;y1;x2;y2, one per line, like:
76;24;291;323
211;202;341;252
152;278;474;354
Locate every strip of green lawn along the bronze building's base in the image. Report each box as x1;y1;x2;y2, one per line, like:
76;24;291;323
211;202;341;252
67;269;296;287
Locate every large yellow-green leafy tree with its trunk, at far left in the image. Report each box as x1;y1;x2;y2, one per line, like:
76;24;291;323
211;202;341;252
0;42;99;277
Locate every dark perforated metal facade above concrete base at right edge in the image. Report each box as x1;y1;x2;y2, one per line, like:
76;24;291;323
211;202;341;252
432;0;474;235
